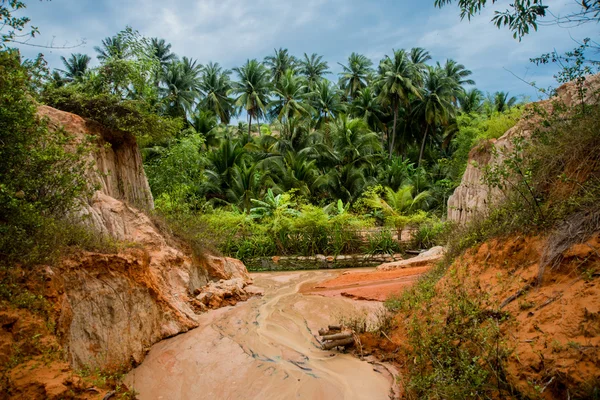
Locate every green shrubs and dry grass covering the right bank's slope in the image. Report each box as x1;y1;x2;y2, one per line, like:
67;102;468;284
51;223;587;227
386;89;600;399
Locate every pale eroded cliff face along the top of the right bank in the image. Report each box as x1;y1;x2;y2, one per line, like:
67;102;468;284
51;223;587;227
448;75;600;224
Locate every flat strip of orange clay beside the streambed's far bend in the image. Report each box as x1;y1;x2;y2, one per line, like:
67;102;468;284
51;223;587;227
301;266;430;301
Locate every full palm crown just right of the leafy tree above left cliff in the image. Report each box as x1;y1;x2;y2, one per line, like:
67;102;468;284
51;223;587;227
160;62;200;117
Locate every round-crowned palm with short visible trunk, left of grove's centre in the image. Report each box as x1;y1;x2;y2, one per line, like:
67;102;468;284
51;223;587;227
230;60;270;134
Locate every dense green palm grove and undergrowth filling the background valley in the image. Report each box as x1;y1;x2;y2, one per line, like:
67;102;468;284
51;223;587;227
16;28;521;260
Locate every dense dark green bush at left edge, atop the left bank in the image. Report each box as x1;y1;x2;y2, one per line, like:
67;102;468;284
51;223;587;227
0;50;106;265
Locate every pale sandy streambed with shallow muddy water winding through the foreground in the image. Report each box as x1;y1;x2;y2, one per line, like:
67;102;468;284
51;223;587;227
126;271;393;400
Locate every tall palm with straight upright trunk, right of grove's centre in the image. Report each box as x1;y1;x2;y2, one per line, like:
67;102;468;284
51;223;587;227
378;50;421;158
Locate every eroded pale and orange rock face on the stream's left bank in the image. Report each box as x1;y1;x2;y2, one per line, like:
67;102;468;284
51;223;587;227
39;106;251;368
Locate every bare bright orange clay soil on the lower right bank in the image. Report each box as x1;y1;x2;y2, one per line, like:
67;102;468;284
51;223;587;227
361;232;600;399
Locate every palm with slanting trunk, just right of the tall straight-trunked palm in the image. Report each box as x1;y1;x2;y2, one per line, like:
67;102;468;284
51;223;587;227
414;67;455;166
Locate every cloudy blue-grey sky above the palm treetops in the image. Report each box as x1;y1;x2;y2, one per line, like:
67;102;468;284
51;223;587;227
14;0;599;100
